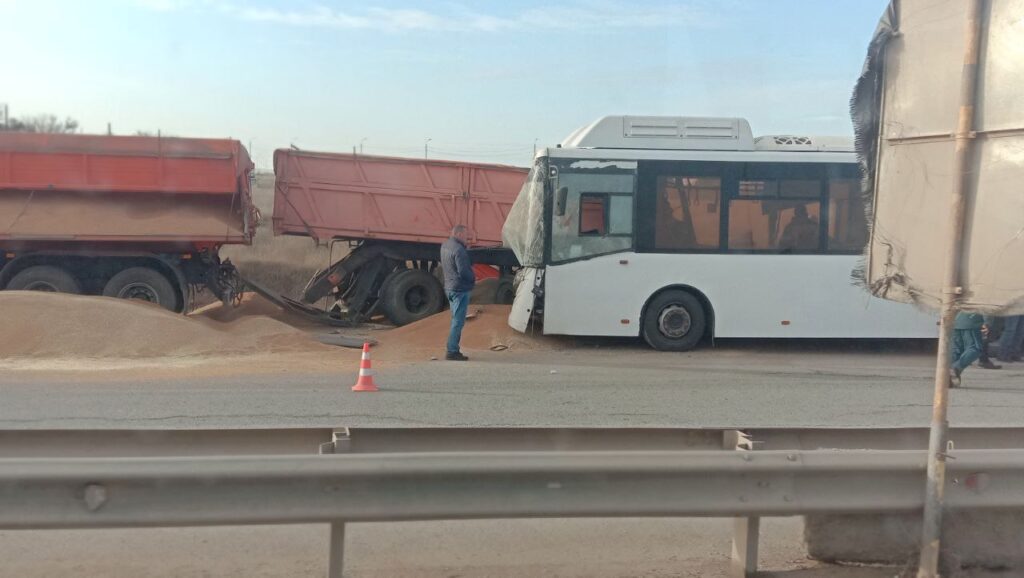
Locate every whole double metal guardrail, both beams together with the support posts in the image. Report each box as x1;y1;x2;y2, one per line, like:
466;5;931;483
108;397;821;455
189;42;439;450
6;428;1024;577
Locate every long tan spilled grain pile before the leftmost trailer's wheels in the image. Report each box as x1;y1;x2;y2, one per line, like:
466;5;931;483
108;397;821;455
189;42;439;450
0;291;334;359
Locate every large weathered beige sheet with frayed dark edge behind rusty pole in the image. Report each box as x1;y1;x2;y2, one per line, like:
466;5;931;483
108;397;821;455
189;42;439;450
851;0;1024;314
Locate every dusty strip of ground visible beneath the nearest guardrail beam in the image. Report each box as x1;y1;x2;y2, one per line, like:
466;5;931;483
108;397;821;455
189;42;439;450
0;518;913;578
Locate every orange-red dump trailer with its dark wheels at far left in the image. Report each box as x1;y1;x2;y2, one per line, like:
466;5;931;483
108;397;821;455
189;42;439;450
0;132;258;312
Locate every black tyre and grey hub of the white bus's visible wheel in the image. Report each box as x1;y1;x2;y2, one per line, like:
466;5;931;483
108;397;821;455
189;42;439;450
641;289;708;352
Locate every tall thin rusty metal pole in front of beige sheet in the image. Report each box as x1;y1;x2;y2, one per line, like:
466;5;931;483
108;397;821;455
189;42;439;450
918;0;984;578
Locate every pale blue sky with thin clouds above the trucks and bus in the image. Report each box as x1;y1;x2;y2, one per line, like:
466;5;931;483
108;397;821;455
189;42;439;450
0;0;887;168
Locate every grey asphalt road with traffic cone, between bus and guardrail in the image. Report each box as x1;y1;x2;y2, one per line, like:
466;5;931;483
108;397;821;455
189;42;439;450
0;342;1024;428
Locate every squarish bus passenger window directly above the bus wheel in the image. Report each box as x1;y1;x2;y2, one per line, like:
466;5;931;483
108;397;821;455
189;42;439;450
654;176;722;249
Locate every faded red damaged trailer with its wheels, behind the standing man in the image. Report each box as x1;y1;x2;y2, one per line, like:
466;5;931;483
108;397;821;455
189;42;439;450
273;149;527;325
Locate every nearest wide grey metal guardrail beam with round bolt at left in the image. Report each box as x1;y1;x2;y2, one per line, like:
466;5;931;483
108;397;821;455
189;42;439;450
0;450;1024;529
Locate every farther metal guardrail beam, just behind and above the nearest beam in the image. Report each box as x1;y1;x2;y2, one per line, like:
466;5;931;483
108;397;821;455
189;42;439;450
6;427;1024;458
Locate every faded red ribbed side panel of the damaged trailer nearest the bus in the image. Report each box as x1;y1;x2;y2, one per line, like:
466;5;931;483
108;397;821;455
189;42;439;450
273;150;527;246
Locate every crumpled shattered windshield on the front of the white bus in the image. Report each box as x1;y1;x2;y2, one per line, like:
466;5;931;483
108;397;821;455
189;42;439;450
502;157;545;266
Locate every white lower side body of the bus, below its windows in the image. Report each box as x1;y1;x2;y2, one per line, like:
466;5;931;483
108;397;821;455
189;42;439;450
544;252;938;338
